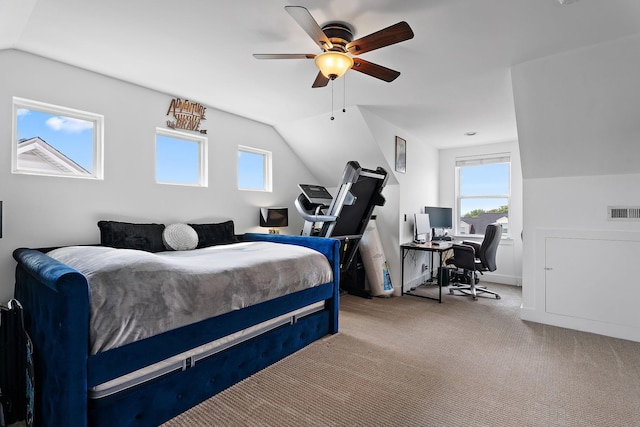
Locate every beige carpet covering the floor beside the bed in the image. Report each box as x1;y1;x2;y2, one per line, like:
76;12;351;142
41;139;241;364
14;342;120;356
165;285;640;427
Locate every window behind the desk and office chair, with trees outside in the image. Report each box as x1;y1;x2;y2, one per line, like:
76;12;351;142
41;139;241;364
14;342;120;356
456;154;511;235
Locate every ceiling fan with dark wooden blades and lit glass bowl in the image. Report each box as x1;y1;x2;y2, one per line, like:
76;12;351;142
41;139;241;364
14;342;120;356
253;6;413;87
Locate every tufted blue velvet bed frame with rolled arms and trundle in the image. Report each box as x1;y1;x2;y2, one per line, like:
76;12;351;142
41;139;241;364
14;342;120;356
14;233;340;427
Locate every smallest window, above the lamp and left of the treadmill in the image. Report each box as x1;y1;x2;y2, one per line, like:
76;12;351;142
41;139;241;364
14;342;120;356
238;146;271;191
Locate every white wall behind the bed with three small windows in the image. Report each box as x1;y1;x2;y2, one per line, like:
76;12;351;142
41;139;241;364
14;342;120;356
0;50;314;301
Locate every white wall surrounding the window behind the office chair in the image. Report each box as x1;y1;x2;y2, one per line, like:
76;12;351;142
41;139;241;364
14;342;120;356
439;141;523;285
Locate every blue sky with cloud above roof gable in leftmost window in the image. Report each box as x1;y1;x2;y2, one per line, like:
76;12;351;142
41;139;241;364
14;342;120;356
16;108;94;173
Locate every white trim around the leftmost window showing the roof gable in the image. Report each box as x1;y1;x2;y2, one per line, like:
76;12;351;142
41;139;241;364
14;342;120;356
11;96;104;180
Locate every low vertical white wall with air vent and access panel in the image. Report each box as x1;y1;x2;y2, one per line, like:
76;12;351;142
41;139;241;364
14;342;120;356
521;174;640;341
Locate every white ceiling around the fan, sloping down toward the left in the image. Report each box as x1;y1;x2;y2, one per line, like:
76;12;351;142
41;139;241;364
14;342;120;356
0;0;640;172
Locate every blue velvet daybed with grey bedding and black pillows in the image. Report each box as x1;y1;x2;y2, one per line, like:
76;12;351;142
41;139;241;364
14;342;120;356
14;222;340;426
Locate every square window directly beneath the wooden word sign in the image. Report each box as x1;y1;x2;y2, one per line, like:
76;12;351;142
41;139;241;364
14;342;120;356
156;128;207;187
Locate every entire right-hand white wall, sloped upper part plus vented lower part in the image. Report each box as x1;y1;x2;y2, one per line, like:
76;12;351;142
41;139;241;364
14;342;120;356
512;33;640;340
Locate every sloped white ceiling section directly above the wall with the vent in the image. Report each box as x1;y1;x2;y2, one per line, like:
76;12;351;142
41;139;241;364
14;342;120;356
513;36;640;178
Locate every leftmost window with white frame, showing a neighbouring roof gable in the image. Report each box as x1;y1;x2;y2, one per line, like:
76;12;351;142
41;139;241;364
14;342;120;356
12;97;104;179
